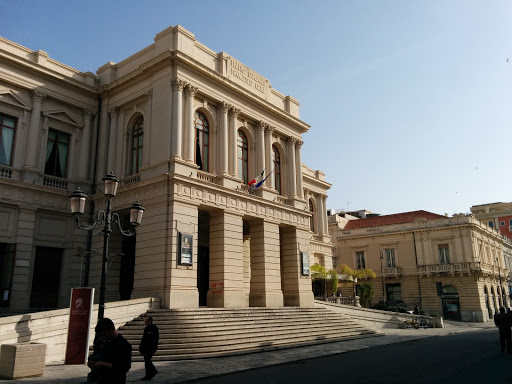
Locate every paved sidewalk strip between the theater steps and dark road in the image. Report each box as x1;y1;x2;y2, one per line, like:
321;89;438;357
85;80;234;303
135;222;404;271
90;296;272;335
0;321;496;384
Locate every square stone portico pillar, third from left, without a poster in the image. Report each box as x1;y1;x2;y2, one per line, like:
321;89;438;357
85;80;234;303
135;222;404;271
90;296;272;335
249;220;283;307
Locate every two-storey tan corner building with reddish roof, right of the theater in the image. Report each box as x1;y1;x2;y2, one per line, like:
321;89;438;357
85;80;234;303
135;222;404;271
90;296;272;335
329;211;512;322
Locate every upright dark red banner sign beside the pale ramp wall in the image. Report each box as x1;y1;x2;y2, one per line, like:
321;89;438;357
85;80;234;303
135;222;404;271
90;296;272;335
64;288;94;364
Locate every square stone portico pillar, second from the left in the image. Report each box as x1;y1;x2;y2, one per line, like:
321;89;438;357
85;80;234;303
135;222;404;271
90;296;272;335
207;212;246;308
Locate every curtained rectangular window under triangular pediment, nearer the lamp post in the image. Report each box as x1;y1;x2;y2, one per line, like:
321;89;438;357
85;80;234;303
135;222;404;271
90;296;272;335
44;129;70;177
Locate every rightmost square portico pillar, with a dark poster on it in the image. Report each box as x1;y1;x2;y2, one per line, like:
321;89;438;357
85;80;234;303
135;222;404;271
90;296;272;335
281;228;315;307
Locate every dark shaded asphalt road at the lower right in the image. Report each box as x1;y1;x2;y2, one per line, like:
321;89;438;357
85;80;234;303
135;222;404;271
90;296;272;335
191;329;512;384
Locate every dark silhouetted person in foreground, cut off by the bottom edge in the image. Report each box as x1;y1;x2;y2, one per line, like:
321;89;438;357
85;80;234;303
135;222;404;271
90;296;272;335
87;317;132;384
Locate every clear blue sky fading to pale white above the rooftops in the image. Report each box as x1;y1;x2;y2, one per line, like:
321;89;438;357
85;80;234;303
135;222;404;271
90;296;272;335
0;0;512;215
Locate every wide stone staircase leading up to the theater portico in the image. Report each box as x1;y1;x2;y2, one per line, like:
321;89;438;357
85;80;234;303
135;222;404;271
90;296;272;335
119;307;380;361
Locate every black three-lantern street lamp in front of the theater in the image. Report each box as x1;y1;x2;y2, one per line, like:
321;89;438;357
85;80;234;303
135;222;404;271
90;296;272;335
69;172;144;320
